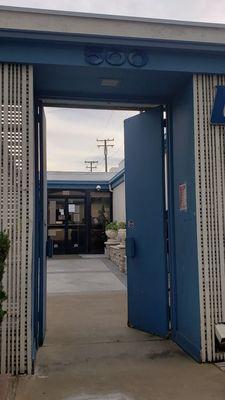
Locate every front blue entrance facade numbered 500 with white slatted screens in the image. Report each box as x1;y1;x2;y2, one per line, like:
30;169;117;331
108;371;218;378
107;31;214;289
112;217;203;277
0;7;225;374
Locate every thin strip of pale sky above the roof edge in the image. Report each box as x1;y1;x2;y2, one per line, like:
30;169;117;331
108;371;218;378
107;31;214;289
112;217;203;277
1;0;225;22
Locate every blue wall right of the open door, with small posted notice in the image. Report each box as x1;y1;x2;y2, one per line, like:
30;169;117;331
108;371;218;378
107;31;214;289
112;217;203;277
170;79;201;360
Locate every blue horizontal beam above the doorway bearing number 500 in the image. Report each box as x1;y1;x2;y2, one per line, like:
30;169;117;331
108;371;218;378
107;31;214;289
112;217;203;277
0;36;225;73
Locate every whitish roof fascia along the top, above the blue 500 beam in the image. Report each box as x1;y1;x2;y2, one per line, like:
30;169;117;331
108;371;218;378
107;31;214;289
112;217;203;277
0;6;225;45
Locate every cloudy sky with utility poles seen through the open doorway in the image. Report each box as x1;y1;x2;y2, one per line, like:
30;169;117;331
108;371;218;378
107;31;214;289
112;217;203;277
45;108;137;171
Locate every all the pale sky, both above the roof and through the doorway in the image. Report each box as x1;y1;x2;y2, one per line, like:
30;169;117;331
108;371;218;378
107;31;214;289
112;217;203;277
1;0;225;171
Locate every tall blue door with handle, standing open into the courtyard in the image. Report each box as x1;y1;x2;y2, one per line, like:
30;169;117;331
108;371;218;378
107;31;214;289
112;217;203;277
124;107;169;337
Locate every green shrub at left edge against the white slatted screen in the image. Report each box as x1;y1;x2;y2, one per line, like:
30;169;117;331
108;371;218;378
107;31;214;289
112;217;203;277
0;232;10;324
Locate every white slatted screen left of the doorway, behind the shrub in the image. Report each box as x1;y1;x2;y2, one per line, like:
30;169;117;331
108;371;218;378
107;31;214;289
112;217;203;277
0;64;34;374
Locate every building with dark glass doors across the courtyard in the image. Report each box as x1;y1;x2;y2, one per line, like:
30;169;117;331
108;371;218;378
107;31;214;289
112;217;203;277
47;169;125;254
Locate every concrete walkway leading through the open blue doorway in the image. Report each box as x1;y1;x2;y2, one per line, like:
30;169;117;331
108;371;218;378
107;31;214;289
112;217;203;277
16;258;225;400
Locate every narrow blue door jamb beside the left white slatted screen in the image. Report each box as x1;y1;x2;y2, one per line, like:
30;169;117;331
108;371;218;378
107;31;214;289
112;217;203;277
32;102;47;365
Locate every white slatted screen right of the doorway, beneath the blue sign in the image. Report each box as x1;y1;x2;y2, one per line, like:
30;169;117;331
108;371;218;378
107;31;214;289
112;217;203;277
194;75;225;361
